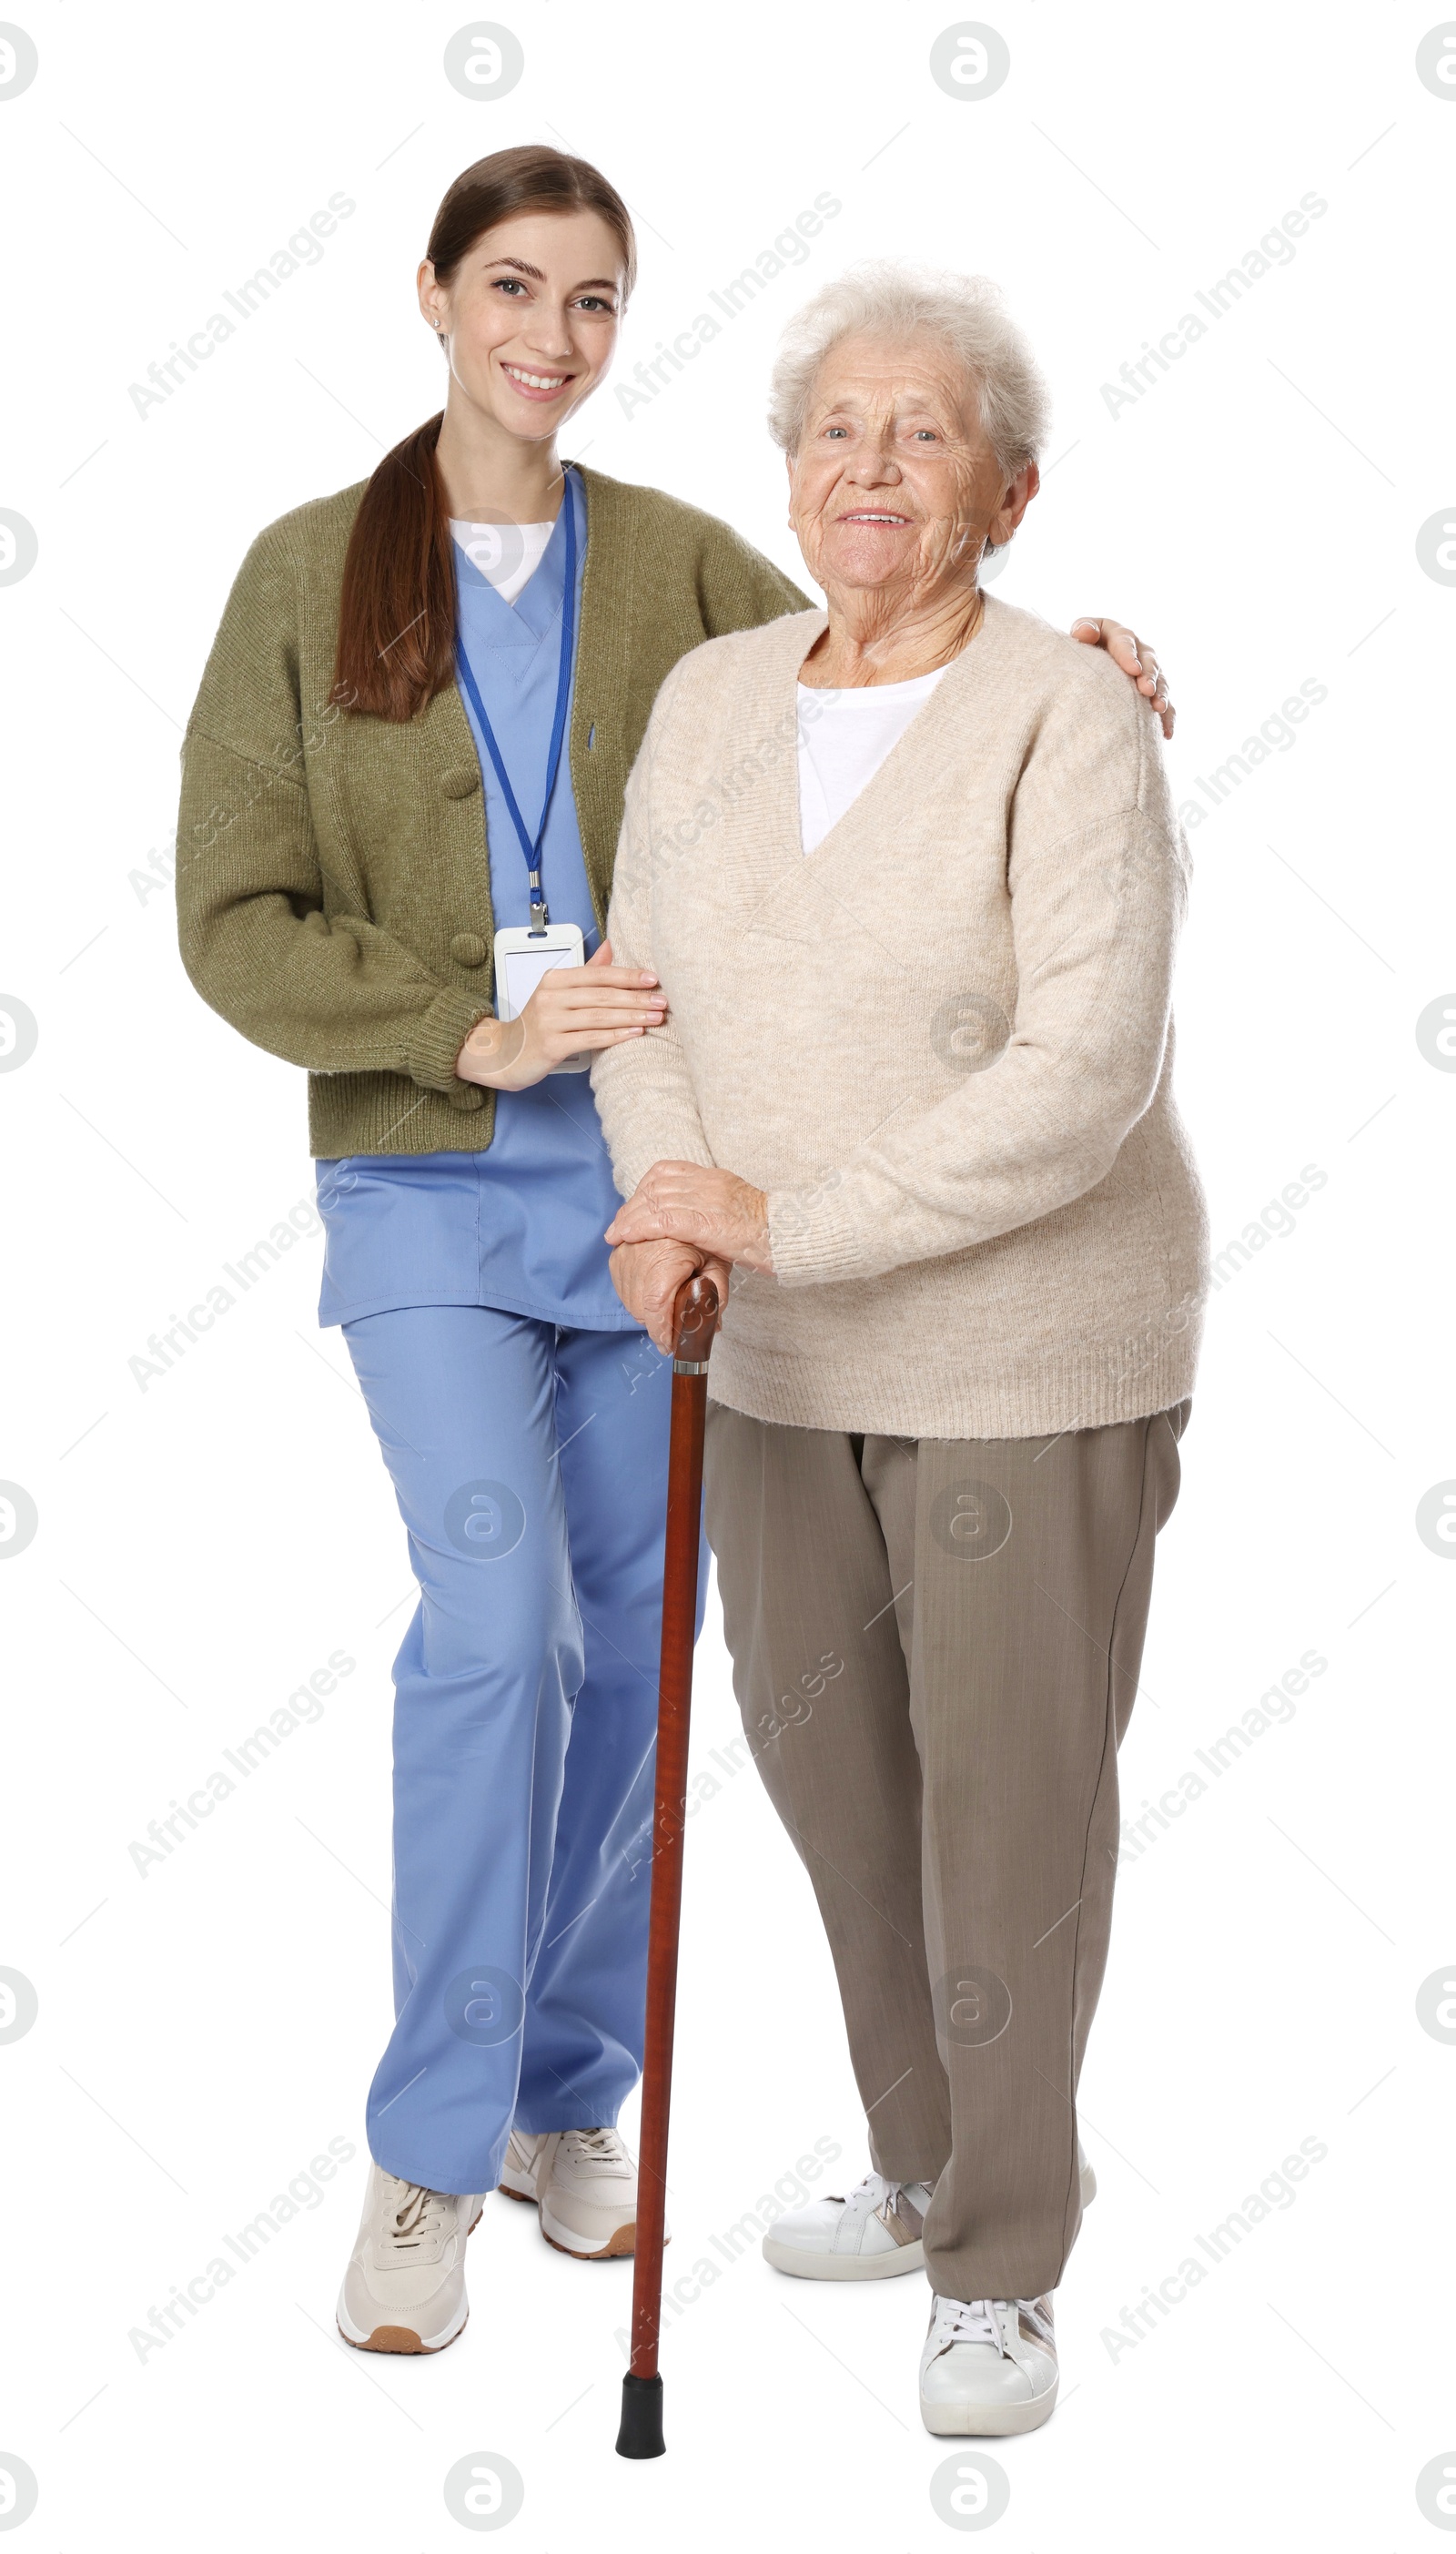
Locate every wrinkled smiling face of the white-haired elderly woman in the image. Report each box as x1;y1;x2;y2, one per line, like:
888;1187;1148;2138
789;335;1037;615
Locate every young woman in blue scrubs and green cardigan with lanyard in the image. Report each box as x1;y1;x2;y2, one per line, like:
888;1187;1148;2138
177;148;1172;2352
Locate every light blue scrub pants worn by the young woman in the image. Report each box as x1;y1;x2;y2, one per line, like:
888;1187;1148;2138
342;1305;689;2192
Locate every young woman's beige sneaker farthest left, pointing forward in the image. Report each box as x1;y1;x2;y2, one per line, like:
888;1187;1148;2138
338;2164;485;2352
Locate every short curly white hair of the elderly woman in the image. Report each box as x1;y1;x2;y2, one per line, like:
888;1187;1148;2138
769;258;1050;478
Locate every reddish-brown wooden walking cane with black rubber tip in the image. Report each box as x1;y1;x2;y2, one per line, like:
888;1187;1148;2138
615;1277;723;2457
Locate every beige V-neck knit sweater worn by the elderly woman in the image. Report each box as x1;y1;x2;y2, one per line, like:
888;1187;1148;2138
592;598;1206;1438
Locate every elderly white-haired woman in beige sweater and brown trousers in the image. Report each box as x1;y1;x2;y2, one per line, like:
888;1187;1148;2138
592;266;1206;2437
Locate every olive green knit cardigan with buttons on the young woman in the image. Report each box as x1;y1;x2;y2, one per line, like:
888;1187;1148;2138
177;470;804;1157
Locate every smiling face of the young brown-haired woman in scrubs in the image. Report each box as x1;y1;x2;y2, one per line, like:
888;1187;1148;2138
419;212;623;441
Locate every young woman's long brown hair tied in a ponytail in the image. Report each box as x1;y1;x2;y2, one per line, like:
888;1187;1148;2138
332;143;636;720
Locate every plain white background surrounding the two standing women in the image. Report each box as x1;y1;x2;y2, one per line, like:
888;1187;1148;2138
0;0;1456;2554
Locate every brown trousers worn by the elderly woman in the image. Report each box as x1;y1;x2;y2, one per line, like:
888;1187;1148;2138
708;1402;1190;2298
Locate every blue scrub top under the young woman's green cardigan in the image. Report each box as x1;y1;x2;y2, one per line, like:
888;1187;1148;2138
319;470;639;1331
